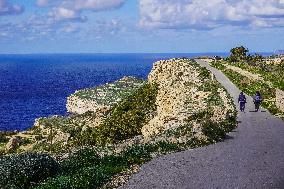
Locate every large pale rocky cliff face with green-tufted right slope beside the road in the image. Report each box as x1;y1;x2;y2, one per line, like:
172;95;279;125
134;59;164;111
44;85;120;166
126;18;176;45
142;59;234;141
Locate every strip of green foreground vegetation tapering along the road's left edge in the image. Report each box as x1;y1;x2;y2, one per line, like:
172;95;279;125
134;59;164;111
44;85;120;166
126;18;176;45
33;138;205;189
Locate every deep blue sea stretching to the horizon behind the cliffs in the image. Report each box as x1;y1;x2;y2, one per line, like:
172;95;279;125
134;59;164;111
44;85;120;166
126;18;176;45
0;53;270;131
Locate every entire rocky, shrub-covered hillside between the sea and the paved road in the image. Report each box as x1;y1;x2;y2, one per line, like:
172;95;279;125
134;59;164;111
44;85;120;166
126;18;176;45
0;58;236;188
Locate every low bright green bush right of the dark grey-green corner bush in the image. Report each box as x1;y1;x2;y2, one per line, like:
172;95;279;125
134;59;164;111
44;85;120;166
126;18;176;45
37;148;128;189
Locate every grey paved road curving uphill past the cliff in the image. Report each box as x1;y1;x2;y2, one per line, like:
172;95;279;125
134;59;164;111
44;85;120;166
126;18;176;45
123;61;284;189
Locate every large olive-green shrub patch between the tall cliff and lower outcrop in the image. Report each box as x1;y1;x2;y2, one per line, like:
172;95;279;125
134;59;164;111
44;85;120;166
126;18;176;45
93;84;157;144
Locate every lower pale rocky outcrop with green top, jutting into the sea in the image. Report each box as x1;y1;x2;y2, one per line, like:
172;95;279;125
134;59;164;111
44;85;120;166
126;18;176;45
66;77;144;114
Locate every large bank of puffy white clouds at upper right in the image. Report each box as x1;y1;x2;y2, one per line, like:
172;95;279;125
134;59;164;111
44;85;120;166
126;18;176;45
139;0;284;29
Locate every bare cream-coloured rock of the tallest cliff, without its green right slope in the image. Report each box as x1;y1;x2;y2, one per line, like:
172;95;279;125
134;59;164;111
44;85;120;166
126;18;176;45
142;59;203;138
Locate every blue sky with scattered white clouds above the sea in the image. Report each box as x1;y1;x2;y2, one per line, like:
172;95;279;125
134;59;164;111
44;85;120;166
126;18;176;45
0;0;284;54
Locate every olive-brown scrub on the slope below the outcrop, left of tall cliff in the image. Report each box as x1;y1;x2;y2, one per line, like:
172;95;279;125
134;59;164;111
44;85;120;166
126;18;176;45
28;83;158;153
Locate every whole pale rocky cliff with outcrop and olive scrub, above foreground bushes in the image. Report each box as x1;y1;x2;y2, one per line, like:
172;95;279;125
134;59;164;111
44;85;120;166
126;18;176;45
0;58;236;156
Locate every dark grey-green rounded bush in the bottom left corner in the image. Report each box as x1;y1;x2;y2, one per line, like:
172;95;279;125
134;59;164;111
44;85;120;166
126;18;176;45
0;153;60;188
